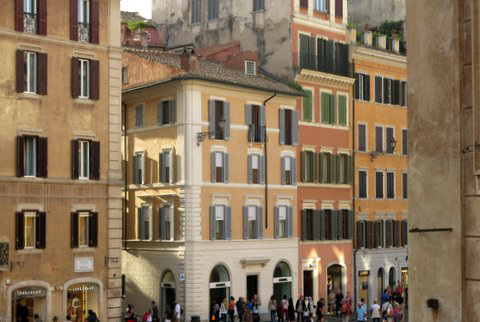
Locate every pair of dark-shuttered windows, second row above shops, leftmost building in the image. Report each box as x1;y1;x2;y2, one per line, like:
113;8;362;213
17;135;100;180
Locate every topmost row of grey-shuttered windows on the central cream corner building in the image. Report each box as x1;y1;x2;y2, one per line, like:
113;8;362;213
134;100;298;145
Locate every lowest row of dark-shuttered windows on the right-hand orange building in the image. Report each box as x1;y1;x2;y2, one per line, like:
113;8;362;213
357;220;408;248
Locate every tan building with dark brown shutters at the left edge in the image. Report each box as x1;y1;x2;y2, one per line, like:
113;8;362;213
0;0;122;321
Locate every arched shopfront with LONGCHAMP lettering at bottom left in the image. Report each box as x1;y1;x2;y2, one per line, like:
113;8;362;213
12;286;47;321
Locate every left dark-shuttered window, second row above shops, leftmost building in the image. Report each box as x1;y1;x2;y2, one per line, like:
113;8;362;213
17;135;48;178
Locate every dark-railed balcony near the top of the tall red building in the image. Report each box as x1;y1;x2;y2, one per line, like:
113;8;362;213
293;52;350;77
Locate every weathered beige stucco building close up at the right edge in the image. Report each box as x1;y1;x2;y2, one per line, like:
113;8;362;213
407;0;480;322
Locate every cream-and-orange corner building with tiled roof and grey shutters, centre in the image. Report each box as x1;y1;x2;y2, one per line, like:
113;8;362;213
122;50;300;320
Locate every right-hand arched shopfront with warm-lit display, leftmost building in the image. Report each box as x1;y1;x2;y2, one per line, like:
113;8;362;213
67;283;100;322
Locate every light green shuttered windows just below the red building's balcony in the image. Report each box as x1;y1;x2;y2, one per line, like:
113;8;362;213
302;89;348;127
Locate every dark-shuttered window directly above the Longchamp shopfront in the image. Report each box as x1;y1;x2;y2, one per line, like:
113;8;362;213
15;210;47;249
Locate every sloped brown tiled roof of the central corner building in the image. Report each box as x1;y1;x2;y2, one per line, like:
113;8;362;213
124;48;303;96
